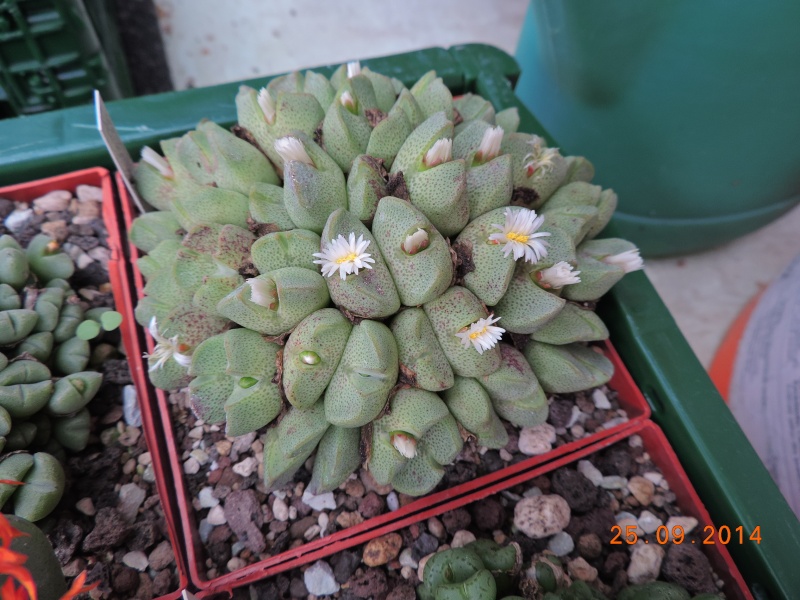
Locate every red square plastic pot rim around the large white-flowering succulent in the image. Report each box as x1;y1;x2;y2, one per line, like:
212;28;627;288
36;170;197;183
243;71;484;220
118;176;650;589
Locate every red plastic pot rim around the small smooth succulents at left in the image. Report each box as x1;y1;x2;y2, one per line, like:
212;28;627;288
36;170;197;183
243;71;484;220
0;167;189;600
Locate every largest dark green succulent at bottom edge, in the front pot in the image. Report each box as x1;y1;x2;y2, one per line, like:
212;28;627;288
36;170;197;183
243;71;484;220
417;540;522;600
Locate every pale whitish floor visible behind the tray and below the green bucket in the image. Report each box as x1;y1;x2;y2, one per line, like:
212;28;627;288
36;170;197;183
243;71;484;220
155;0;800;366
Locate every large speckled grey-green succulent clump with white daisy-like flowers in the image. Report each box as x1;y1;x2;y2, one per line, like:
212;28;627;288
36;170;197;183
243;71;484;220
130;63;642;495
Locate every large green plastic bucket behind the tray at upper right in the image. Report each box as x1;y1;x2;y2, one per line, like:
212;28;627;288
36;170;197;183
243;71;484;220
517;0;800;256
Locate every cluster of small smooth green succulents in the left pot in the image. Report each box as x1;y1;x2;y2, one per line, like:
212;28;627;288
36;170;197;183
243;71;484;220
0;235;119;521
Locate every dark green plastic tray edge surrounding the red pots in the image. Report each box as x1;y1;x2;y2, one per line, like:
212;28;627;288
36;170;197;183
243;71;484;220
0;44;800;600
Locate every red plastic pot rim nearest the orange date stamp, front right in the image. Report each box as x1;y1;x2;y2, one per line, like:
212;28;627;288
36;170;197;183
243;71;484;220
198;420;756;600
